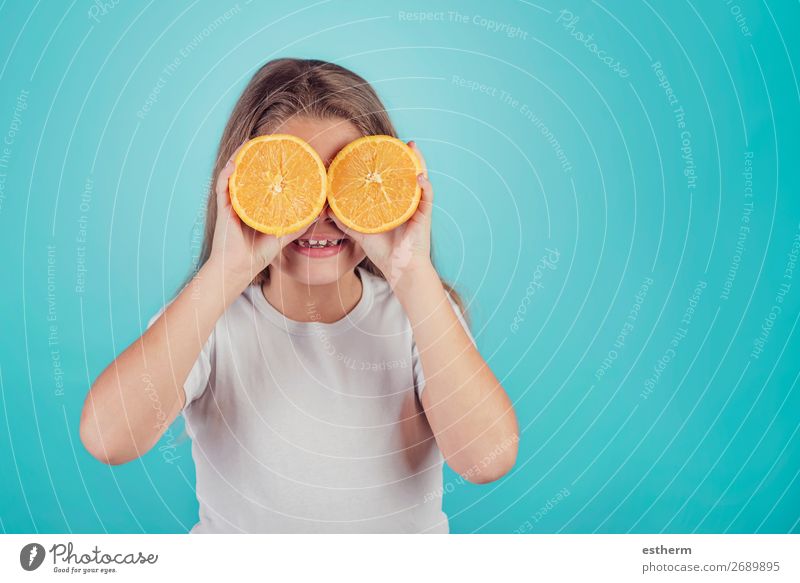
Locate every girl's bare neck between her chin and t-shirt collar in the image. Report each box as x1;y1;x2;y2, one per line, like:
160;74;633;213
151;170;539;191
261;269;362;324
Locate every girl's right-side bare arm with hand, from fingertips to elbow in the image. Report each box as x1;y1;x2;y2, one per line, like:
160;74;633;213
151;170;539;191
334;142;519;483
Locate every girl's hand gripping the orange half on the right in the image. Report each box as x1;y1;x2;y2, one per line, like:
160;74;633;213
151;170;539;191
329;141;433;288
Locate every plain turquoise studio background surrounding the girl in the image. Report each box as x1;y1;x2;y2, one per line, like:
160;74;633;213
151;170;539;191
0;0;800;533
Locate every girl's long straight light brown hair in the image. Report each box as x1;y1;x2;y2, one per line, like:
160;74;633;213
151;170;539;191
197;58;466;316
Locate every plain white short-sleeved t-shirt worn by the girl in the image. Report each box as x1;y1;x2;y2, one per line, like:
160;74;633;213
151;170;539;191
150;268;471;533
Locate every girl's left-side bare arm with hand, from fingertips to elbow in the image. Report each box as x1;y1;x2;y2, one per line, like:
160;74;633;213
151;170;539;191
80;155;299;464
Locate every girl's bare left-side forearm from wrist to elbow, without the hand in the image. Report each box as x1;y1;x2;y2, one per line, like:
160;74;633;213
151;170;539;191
81;261;246;464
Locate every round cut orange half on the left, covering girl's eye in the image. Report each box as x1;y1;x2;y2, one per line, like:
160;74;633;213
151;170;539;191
228;134;327;237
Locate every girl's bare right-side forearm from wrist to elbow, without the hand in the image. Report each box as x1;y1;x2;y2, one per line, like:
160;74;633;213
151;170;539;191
395;265;518;482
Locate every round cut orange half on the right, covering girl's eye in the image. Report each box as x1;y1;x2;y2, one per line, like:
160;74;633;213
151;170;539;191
328;136;422;233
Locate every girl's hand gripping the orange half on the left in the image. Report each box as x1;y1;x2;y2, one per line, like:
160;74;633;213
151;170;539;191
209;150;303;286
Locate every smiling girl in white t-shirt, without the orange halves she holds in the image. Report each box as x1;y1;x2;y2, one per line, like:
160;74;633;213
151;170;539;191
80;59;518;533
